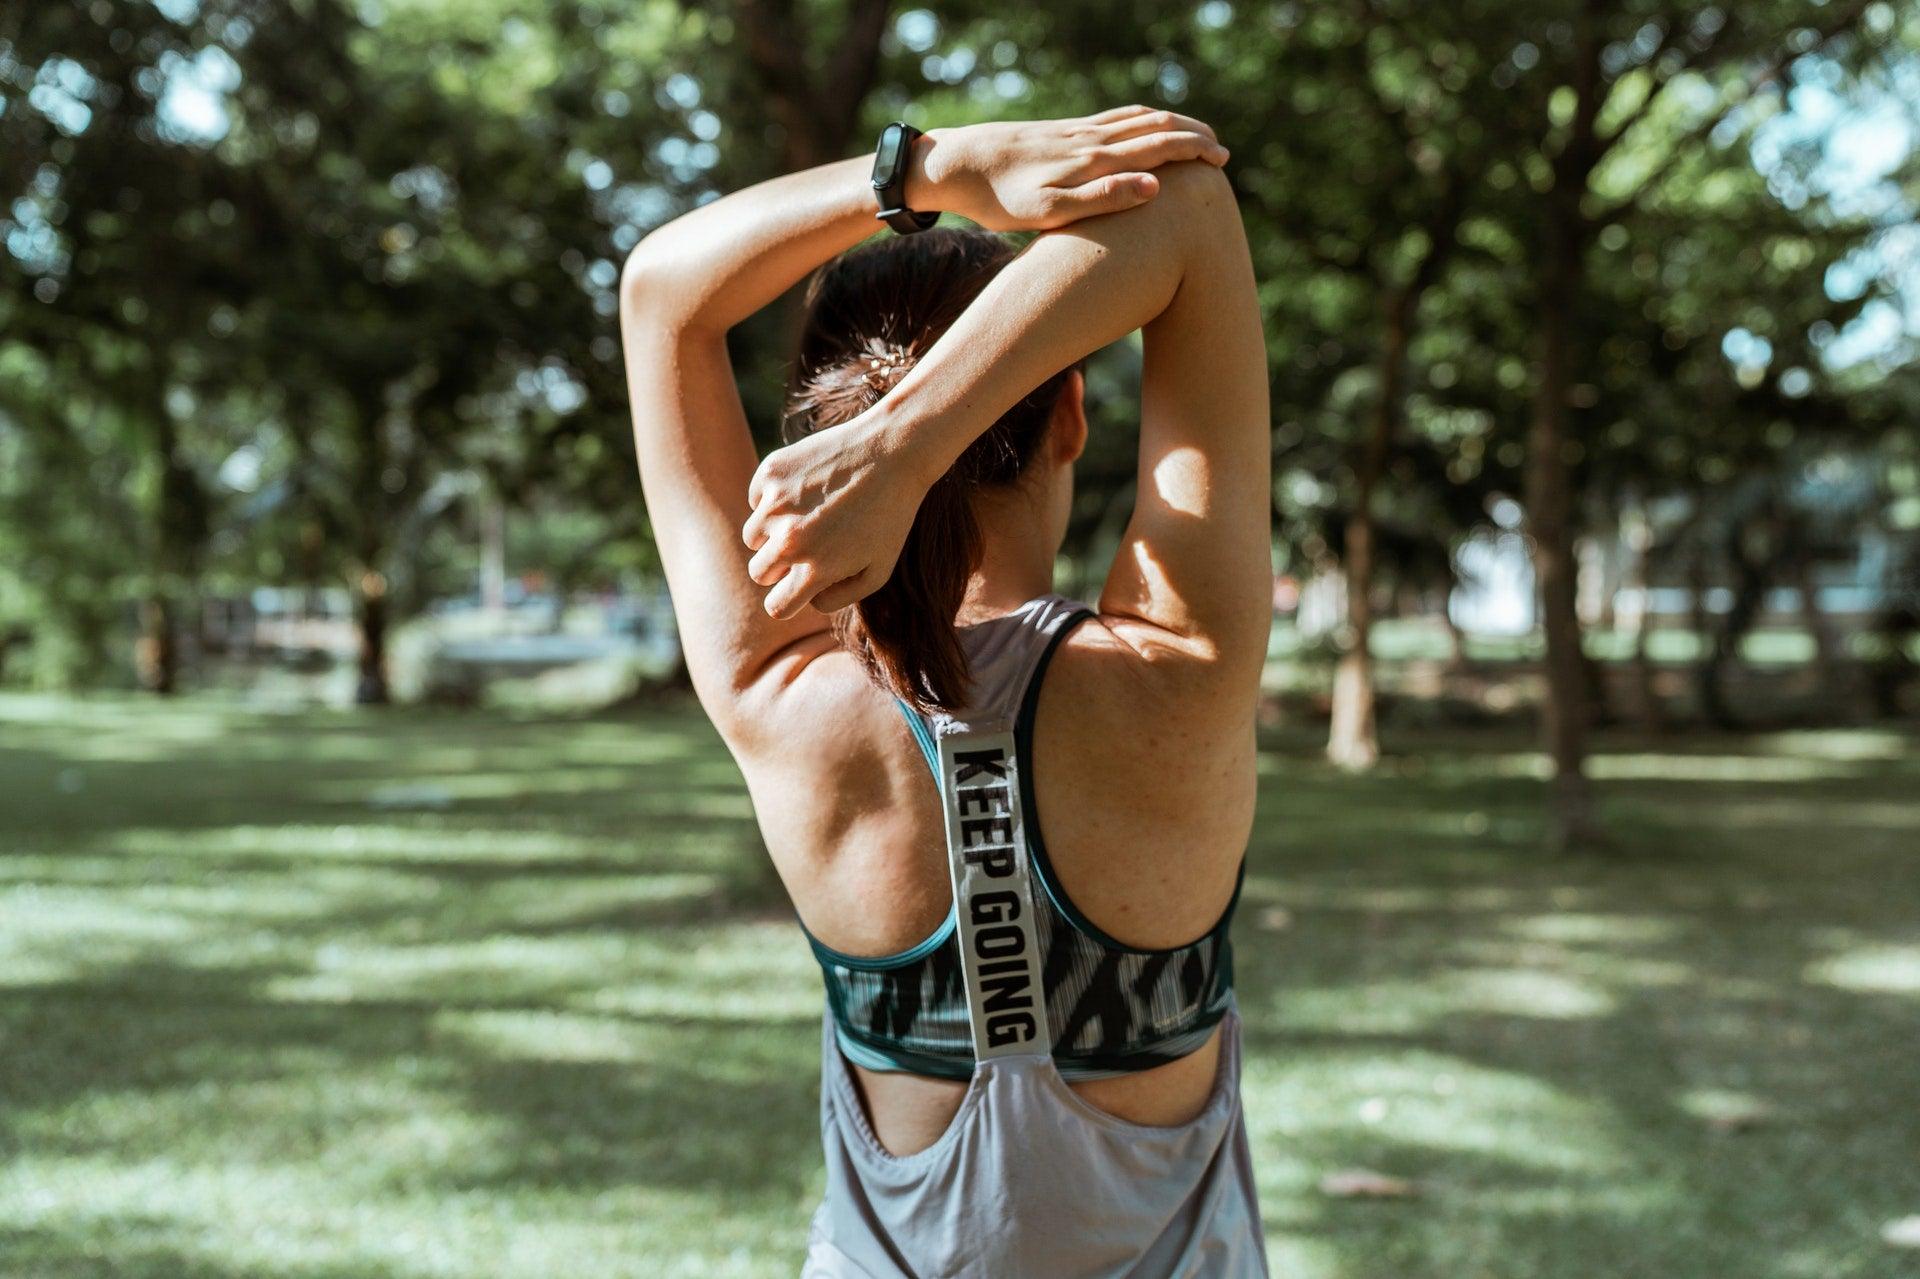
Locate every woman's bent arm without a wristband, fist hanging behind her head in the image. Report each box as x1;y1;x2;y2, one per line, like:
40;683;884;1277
743;165;1271;691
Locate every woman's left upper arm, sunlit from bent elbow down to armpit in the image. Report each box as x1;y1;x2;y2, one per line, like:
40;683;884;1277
622;265;831;732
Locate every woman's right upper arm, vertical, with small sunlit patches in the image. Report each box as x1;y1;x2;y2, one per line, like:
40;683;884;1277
1100;167;1273;689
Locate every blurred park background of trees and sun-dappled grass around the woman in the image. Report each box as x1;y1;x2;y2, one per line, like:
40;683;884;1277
0;0;1920;1279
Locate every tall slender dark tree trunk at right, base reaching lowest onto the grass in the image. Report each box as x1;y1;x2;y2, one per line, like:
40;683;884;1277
1526;209;1597;851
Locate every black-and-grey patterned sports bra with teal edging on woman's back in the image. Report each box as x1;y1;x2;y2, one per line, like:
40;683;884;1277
803;595;1246;1079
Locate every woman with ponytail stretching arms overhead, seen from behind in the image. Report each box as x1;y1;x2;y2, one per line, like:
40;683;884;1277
622;108;1271;1279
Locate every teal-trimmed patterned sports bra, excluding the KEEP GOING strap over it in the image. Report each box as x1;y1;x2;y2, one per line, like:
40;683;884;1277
801;595;1246;1079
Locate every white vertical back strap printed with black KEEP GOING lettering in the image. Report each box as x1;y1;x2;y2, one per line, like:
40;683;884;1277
939;722;1050;1060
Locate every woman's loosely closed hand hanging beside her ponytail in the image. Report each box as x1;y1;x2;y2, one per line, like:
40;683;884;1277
741;413;927;618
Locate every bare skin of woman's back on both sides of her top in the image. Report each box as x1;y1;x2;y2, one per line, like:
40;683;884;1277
743;618;1254;1154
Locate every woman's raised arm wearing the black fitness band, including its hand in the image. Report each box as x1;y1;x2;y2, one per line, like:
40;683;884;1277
620;108;1225;730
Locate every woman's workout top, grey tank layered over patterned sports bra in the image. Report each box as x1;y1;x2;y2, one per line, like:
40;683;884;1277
803;595;1267;1279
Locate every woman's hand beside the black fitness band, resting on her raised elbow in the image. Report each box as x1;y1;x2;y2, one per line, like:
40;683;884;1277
906;106;1227;230
